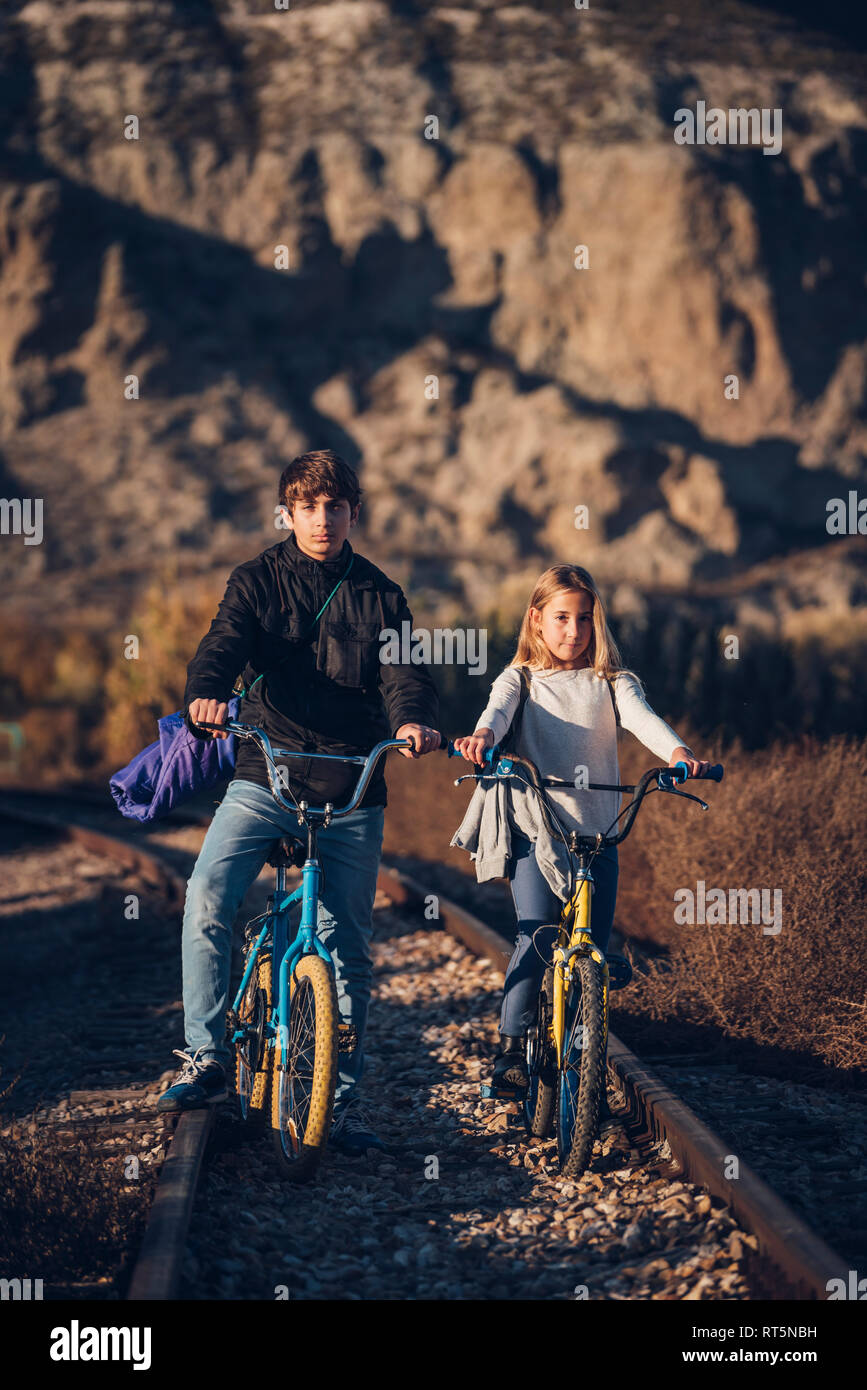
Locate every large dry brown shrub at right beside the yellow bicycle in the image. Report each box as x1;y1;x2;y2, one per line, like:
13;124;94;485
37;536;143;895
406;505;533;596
617;737;867;1070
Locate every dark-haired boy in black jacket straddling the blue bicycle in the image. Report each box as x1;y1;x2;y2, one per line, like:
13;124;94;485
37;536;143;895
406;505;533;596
157;449;439;1155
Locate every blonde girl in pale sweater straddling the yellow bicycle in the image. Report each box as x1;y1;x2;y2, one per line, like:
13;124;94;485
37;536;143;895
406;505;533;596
452;564;709;1120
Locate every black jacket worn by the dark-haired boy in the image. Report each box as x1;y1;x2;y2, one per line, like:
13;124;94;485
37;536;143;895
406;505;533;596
183;532;439;806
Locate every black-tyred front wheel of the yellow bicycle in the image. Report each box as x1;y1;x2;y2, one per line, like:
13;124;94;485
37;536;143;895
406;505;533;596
556;956;607;1177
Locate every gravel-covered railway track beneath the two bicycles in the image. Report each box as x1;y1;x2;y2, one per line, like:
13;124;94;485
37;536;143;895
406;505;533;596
0;792;863;1300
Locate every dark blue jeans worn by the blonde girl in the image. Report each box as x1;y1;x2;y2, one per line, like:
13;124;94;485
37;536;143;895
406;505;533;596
500;830;618;1037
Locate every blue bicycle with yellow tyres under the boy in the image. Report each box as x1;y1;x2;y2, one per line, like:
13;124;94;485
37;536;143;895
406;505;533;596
197;720;422;1183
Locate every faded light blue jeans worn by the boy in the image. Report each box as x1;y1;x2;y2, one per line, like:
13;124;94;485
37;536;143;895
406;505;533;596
182;778;385;1115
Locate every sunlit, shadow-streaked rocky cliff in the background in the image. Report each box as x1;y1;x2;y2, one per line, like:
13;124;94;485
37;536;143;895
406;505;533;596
0;0;867;695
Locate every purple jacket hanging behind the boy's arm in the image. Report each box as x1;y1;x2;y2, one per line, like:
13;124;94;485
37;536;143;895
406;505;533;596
108;699;240;821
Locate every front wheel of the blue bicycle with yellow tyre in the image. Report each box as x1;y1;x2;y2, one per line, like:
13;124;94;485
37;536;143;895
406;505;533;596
271;955;338;1183
